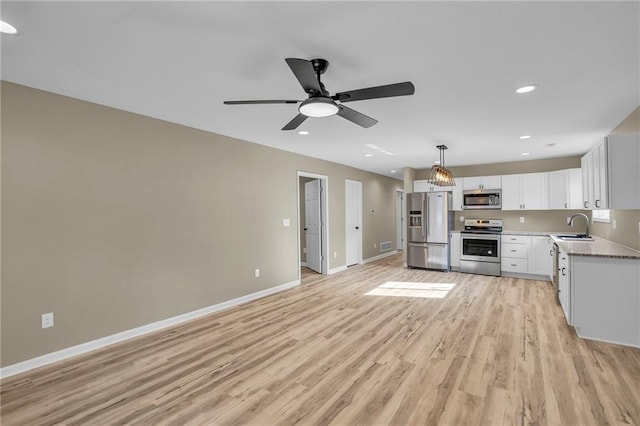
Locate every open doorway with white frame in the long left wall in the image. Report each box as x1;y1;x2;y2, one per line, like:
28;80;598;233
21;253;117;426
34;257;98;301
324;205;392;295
297;171;329;280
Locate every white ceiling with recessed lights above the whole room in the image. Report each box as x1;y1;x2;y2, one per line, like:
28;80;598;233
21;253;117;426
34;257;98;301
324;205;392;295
1;1;640;178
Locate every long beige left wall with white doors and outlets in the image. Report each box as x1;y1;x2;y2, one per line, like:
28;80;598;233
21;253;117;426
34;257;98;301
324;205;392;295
1;82;402;366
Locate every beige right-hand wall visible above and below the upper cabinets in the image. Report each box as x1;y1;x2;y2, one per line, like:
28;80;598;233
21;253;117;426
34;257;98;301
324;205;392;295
593;107;640;250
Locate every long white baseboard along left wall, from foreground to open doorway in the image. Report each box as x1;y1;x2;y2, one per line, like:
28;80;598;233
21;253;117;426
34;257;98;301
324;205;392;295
0;280;300;379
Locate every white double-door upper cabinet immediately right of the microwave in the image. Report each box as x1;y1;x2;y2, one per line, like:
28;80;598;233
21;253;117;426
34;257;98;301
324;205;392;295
502;173;548;210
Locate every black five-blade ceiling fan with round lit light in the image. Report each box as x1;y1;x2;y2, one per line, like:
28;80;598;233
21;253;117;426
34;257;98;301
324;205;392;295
224;58;415;130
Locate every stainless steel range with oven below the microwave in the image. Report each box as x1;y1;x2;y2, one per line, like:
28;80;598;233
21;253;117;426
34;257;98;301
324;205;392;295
460;219;502;277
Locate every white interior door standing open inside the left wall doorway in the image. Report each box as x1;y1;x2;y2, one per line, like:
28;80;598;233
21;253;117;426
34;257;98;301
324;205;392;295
304;179;322;272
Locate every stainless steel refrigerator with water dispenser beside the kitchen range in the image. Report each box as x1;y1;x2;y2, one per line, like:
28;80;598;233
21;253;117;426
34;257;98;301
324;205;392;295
407;192;453;271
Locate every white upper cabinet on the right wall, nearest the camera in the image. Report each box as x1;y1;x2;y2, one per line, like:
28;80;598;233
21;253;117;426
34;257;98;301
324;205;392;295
581;133;640;210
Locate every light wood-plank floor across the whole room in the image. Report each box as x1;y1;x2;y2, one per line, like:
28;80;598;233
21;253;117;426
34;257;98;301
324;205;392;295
1;255;640;425
